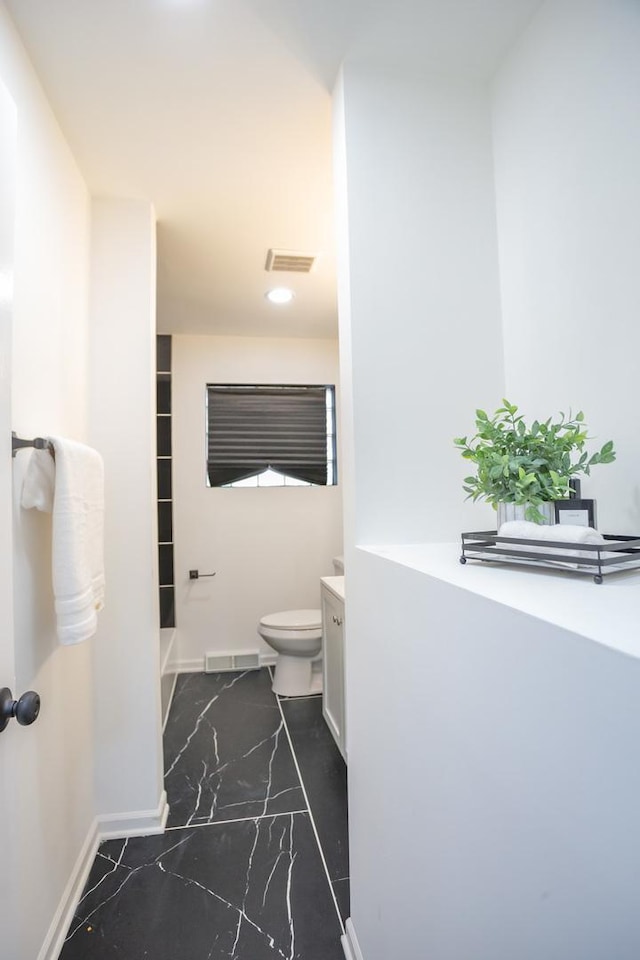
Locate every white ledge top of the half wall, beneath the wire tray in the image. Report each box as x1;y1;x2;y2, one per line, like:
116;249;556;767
360;543;640;659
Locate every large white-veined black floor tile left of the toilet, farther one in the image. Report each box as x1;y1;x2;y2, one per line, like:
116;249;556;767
164;670;306;827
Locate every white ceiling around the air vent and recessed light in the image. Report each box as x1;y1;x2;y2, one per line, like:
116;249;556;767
4;0;540;337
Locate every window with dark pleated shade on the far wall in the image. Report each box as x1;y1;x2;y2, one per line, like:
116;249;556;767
207;383;336;487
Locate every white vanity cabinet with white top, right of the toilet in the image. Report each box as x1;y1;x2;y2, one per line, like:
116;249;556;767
320;577;347;761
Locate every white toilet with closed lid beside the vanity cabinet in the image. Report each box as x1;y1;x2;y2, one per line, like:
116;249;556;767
258;610;322;697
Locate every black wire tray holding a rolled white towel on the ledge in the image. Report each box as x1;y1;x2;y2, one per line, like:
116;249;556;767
460;530;640;583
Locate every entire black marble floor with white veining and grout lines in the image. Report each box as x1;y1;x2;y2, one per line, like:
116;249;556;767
60;670;349;960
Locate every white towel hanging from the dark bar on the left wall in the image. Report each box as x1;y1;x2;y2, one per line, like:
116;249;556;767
22;437;104;644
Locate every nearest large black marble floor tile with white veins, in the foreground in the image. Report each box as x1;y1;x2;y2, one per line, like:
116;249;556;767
60;813;343;960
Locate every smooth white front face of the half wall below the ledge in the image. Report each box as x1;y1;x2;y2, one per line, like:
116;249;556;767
347;551;640;960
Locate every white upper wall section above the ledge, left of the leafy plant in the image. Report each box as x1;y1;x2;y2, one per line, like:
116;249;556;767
336;63;504;543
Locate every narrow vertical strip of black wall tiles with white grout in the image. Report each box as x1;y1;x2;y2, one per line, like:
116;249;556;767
156;334;176;627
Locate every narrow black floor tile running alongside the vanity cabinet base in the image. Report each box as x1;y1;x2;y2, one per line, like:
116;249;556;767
281;697;349;888
